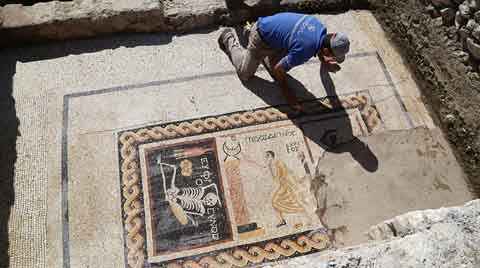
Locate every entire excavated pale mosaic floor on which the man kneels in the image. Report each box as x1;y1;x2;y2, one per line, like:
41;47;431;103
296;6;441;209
3;9;471;268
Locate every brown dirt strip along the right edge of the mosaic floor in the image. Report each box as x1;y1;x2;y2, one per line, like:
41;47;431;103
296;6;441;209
374;0;480;194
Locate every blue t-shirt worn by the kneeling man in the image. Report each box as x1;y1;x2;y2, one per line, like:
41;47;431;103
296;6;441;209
258;12;327;71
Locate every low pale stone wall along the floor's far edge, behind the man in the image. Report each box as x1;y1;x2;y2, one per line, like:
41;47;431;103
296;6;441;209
0;0;368;47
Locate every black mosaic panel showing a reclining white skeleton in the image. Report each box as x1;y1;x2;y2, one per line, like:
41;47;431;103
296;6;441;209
141;138;232;256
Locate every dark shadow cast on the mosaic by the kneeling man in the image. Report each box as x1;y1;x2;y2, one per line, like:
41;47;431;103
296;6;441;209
243;64;378;172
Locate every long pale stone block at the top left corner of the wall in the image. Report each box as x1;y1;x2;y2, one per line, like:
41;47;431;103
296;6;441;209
0;0;165;46
